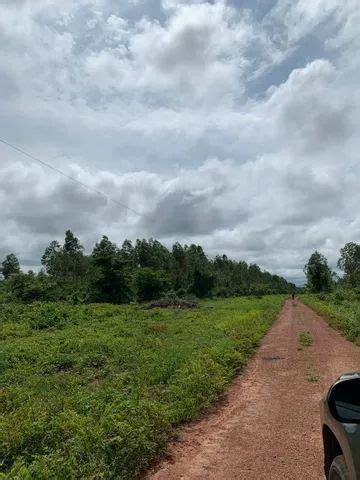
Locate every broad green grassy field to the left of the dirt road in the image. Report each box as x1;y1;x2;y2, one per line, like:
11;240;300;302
0;296;283;480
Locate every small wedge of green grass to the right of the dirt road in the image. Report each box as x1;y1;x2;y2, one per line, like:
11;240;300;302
301;289;360;345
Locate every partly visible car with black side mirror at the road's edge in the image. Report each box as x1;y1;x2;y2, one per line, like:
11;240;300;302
321;373;360;480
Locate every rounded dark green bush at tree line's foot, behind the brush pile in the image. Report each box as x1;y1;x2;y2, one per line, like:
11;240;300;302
136;267;170;302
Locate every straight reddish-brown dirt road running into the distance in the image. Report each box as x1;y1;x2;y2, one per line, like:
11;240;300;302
148;300;360;480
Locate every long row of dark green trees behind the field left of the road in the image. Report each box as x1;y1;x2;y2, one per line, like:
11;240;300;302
1;230;296;303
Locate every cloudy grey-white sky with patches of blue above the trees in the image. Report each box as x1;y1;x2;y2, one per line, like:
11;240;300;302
0;0;360;284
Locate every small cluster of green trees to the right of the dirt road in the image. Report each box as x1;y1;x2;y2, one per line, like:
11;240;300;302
304;242;360;293
